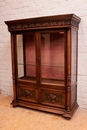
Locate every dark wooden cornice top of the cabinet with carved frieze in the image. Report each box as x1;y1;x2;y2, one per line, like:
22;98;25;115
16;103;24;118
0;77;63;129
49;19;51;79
5;14;81;32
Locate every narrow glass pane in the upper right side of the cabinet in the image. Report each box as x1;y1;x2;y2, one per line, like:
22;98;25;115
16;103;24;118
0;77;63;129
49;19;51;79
71;30;77;84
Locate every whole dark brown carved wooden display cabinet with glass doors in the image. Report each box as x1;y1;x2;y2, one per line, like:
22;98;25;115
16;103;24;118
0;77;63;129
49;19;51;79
5;14;80;118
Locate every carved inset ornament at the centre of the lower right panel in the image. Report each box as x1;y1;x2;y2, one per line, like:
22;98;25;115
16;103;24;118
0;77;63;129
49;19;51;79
44;93;62;103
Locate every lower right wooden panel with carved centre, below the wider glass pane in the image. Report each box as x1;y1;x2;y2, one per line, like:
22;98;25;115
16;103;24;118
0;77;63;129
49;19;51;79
41;90;66;108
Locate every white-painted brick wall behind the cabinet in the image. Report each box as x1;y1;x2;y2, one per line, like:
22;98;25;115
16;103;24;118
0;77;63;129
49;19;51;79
0;0;87;109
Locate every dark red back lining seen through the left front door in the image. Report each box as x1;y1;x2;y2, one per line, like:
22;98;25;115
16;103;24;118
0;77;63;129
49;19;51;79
24;33;36;80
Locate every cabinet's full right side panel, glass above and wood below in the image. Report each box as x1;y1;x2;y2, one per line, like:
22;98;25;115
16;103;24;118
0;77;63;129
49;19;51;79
71;29;78;106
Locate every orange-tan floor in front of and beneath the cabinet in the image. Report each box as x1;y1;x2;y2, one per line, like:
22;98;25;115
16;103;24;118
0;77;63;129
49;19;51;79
0;95;87;130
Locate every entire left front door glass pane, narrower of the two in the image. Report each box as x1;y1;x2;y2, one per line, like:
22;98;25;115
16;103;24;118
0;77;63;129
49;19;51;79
17;33;36;81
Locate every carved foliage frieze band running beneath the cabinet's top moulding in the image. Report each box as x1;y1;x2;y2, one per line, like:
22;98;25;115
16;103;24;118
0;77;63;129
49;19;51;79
8;19;78;31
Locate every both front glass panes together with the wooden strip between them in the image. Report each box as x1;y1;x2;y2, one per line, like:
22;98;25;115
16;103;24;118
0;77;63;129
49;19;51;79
16;31;65;84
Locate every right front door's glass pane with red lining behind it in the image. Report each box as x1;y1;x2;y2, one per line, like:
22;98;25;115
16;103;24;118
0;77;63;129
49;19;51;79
41;32;64;83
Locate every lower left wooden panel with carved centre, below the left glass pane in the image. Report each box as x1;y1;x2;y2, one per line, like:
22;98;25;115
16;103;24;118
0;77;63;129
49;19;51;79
17;85;38;103
